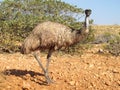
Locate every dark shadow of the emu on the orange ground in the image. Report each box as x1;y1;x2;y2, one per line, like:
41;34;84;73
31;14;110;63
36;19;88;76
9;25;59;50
3;69;47;85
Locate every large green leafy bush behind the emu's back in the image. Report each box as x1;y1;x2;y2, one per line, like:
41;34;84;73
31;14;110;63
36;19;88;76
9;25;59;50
0;0;94;53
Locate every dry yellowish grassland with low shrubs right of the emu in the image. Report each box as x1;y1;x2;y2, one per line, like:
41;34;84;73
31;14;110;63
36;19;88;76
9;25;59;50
93;25;120;56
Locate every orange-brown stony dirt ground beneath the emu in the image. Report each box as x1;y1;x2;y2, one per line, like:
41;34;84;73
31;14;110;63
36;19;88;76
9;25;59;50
0;45;120;90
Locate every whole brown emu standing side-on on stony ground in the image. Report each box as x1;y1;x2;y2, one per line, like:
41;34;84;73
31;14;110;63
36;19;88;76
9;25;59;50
21;9;91;84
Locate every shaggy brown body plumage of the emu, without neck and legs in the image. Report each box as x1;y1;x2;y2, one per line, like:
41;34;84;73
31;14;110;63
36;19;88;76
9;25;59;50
22;21;85;54
